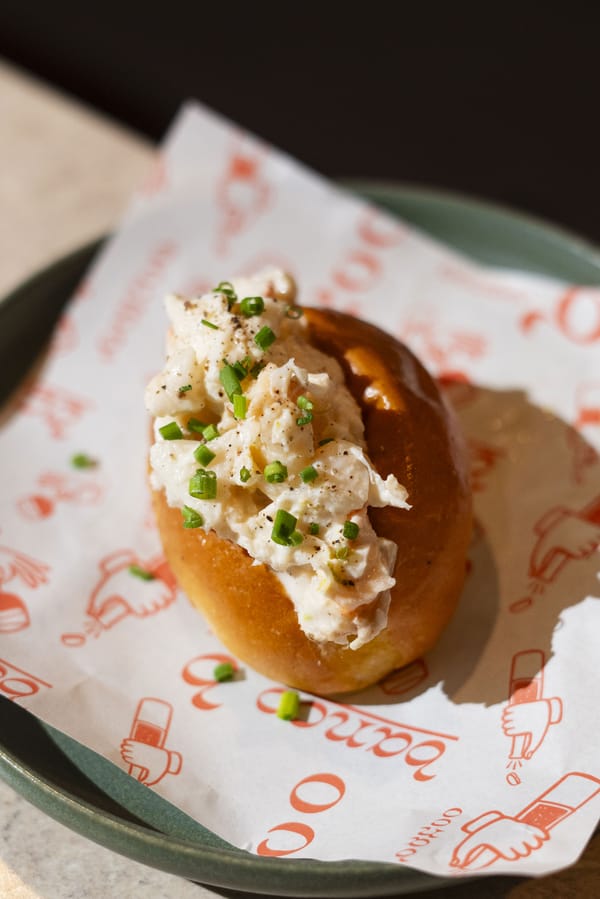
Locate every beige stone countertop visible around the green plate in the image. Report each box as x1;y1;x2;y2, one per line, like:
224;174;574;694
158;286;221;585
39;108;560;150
0;60;600;899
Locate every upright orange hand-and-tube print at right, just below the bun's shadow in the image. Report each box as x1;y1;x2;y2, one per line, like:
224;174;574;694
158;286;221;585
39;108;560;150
502;649;563;786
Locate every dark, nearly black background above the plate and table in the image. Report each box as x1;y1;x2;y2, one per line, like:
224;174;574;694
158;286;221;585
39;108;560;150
0;0;600;242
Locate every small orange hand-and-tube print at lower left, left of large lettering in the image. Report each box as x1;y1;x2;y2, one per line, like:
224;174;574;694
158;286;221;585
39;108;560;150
120;697;182;787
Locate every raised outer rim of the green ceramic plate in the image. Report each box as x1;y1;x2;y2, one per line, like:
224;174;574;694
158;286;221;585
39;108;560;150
0;178;600;897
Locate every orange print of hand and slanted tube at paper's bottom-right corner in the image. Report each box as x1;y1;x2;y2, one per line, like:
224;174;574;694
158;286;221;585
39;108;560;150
450;771;600;871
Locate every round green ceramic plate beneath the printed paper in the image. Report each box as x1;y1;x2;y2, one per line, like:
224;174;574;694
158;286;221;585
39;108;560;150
0;183;600;897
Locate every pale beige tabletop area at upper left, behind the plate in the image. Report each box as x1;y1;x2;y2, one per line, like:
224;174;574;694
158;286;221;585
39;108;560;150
0;60;153;295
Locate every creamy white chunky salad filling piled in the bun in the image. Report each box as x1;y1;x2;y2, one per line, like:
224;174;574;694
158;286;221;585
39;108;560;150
146;269;410;649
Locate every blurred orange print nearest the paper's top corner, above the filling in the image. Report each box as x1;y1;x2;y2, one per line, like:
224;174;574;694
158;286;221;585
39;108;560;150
216;144;273;256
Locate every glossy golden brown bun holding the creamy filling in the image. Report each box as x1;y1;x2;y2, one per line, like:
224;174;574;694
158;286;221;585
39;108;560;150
153;308;471;694
